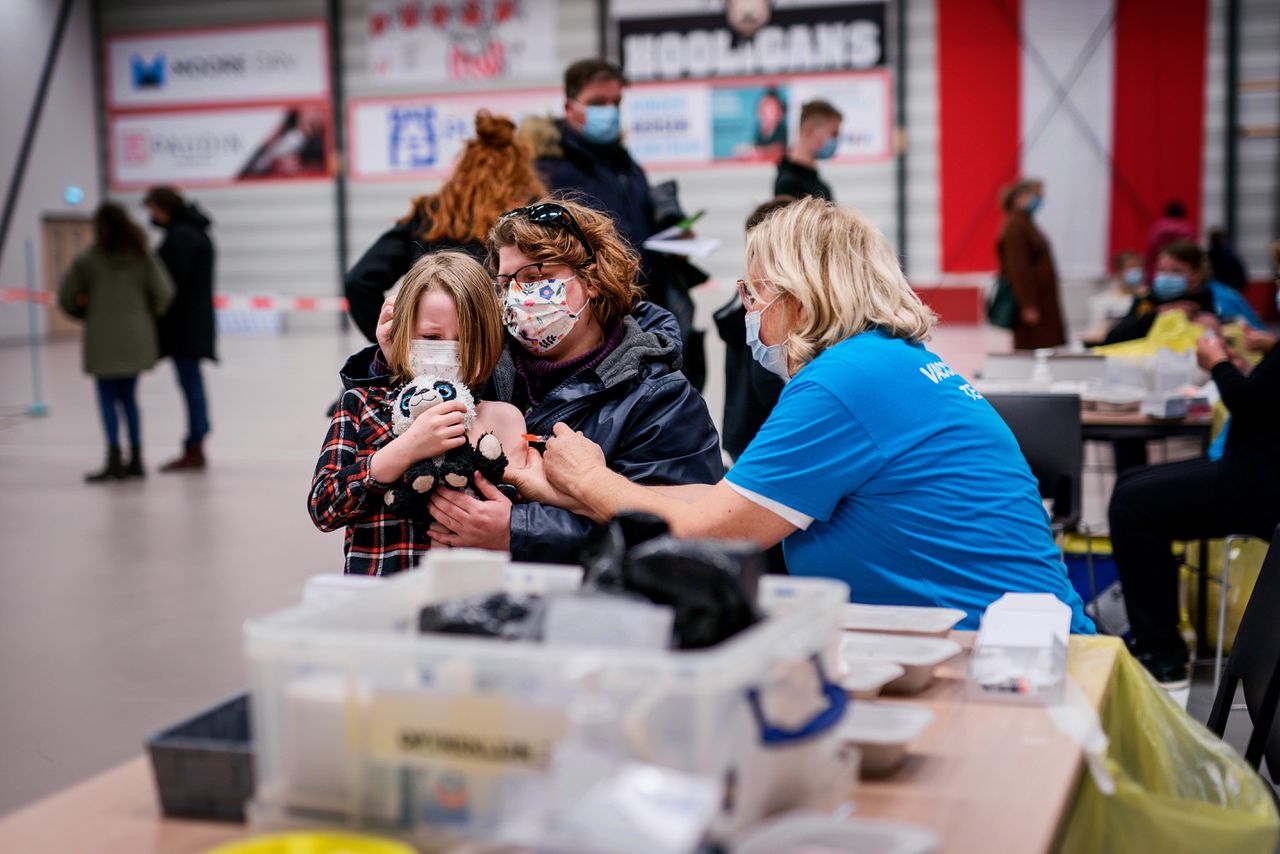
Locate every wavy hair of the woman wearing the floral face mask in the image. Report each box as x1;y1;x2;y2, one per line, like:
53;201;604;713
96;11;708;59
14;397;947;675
489;193;643;329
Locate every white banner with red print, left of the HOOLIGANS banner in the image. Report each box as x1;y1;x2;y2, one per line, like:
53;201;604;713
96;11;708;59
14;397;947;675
366;0;561;83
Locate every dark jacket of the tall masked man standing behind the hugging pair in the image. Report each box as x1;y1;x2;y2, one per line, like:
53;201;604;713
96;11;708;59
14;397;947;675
538;119;655;250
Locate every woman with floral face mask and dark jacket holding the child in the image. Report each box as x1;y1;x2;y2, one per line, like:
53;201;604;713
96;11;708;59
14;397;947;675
343;197;724;563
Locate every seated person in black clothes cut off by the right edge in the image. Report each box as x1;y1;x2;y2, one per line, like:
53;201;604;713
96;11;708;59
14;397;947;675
1110;313;1280;689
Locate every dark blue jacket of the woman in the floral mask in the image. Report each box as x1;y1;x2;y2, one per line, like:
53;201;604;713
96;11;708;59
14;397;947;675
342;302;724;563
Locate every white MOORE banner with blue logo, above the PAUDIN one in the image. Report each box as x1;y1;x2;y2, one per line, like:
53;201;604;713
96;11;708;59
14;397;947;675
104;20;329;110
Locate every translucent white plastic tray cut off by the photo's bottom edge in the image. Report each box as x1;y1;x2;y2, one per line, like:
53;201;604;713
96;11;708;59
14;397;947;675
733;813;938;854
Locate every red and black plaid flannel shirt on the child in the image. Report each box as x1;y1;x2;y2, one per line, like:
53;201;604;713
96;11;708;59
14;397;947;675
307;388;431;575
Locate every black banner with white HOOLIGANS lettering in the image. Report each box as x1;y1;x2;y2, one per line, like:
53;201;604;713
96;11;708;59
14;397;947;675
616;0;884;82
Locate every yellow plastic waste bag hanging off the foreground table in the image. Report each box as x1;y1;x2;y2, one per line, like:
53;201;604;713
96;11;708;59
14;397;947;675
1059;650;1280;854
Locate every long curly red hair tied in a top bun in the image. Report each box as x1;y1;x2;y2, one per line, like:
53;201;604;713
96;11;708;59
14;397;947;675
399;110;547;243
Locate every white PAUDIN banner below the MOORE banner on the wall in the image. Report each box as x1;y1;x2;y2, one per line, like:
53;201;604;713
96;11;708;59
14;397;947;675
109;102;333;191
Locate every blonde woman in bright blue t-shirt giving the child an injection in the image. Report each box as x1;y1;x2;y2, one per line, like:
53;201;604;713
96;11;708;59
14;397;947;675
508;198;1093;634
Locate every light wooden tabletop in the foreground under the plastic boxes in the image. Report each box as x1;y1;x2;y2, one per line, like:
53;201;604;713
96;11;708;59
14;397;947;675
0;632;1121;854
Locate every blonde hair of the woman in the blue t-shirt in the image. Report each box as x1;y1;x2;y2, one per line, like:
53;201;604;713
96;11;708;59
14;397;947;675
746;197;937;374
